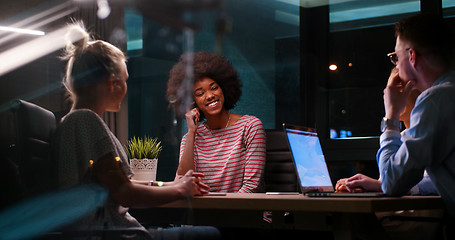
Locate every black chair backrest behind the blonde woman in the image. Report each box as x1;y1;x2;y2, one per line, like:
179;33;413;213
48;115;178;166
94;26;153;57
11;100;57;197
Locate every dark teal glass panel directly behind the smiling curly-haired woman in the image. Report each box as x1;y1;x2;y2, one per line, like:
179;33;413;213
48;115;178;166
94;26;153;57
125;0;300;179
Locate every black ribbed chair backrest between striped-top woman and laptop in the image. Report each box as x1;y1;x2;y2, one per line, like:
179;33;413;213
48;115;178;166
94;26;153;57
264;129;299;192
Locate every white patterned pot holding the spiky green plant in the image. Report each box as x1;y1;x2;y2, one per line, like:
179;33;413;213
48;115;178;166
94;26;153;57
130;158;158;181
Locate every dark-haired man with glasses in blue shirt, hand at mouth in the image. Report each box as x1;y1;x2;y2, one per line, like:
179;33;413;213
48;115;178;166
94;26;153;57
376;11;455;217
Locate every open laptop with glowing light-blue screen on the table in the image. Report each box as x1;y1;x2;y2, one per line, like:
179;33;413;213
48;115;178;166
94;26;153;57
283;123;384;197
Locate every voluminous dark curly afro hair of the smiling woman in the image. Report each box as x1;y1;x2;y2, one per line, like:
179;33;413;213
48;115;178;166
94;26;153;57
166;51;242;117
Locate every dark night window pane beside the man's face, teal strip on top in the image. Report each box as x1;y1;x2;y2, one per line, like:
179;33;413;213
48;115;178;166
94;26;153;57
327;0;420;138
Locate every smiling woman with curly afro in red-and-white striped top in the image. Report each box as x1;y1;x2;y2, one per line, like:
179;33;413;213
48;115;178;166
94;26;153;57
167;52;266;192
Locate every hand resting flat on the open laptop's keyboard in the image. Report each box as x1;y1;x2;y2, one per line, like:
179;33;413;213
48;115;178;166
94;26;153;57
335;173;382;192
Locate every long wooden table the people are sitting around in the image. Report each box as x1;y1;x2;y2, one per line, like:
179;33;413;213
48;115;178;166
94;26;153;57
130;193;444;240
